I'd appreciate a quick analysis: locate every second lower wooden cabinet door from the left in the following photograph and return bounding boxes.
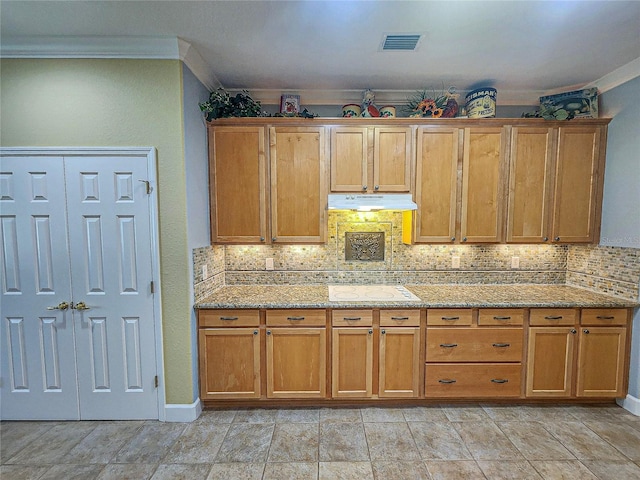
[267,327,327,398]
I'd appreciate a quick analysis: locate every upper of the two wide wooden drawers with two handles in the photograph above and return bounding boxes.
[427,328,523,362]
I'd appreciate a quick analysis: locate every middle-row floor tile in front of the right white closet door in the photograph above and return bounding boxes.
[61,422,142,464]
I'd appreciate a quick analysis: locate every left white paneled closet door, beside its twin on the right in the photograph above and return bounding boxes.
[0,157,80,420]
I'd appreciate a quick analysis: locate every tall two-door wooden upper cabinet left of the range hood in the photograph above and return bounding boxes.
[209,124,328,244]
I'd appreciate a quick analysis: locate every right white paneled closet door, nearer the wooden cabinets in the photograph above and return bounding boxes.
[65,156,158,419]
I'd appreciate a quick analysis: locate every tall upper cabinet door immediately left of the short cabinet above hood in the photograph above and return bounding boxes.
[270,127,327,243]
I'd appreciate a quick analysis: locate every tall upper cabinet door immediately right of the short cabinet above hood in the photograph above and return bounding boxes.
[414,127,459,243]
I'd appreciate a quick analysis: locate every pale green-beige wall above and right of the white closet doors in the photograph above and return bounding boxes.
[0,59,195,403]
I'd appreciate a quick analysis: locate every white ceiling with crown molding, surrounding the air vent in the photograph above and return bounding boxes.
[0,0,640,104]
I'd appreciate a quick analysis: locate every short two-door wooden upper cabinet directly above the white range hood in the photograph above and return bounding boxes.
[330,126,413,193]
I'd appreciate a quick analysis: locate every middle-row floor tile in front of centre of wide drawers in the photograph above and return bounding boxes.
[454,421,523,461]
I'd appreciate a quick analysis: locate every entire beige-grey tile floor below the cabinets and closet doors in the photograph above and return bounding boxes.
[0,404,640,480]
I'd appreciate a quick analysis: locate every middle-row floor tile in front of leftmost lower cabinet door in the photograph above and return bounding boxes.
[216,423,274,463]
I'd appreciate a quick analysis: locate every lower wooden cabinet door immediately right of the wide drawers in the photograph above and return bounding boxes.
[526,326,577,397]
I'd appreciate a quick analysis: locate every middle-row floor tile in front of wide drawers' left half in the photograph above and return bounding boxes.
[408,422,473,460]
